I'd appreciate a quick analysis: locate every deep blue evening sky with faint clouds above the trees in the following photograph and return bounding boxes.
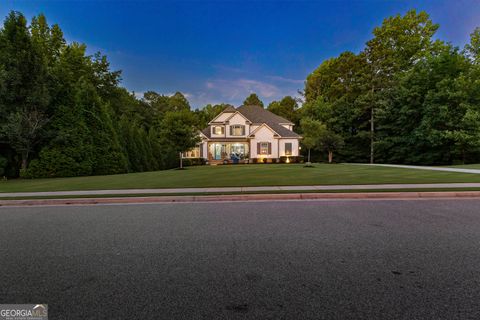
[0,0,480,107]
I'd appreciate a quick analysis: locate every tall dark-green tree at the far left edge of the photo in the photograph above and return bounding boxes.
[0,12,50,170]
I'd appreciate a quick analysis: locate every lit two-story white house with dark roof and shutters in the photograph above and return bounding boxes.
[185,105,301,164]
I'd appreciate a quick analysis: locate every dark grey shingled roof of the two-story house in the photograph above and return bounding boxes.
[202,105,301,139]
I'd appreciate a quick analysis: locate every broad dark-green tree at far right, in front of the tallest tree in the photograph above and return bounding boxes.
[375,43,474,164]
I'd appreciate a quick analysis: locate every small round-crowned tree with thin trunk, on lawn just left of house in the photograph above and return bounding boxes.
[159,110,199,169]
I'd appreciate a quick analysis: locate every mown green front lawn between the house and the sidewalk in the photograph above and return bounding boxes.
[0,164,480,192]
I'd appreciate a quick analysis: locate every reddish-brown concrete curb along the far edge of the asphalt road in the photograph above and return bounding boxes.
[0,191,480,207]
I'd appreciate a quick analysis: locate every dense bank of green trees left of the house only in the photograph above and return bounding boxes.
[0,12,201,178]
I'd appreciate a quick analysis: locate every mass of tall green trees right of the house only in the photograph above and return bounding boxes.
[298,10,480,165]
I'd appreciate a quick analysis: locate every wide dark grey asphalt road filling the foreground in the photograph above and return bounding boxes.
[0,200,480,320]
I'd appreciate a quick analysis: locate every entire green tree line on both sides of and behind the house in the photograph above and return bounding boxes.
[0,10,480,178]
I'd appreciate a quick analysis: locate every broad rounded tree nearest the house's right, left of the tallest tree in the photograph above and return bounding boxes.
[306,52,370,162]
